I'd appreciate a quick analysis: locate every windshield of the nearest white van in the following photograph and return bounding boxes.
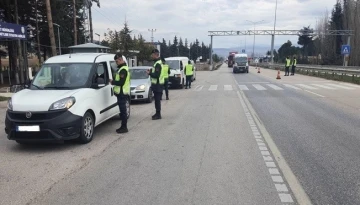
[30,63,93,90]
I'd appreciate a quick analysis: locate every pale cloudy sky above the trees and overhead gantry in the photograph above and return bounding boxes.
[92,0,336,50]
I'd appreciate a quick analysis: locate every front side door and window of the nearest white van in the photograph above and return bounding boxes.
[94,62,116,122]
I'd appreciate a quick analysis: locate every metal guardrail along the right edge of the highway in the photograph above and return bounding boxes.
[250,63,360,84]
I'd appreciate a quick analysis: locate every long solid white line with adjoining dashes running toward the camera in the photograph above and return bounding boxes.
[237,91,311,204]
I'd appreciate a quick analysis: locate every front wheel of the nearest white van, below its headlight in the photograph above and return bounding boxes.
[78,112,95,144]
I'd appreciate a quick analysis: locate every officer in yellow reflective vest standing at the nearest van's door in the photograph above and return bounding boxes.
[110,53,130,134]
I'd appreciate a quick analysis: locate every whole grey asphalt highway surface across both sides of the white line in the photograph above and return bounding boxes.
[0,64,360,205]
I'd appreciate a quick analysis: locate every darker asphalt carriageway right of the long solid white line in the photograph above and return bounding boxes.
[229,68,360,204]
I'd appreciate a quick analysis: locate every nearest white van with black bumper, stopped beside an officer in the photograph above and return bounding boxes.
[5,53,130,144]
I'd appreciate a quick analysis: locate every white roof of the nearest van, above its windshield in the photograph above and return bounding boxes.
[45,53,115,63]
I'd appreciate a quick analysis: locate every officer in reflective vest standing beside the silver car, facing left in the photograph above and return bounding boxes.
[147,49,165,120]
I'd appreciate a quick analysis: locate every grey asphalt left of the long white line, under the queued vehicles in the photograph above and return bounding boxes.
[0,67,296,205]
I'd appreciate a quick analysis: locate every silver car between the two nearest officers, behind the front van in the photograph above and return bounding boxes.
[129,66,153,103]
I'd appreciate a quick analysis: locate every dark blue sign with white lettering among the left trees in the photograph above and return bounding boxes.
[0,22,27,40]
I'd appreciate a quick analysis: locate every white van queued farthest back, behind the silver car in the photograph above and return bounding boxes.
[165,57,196,88]
